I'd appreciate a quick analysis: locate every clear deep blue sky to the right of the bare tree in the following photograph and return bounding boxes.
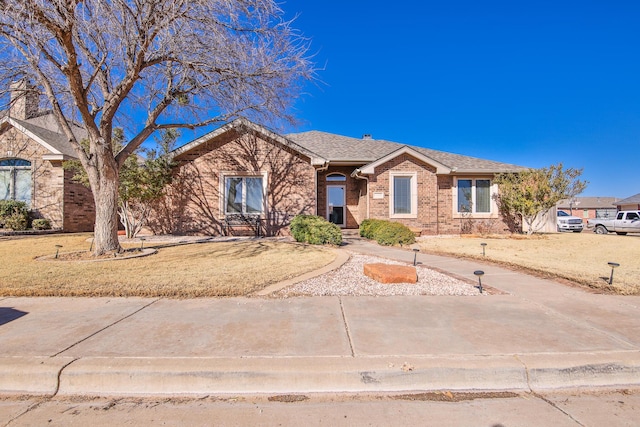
[282,0,640,198]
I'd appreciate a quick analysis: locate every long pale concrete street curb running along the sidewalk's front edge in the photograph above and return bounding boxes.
[0,351,624,396]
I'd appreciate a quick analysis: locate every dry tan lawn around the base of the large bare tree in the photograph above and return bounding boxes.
[0,234,335,298]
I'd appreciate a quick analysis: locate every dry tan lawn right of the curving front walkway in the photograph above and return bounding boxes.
[420,231,640,295]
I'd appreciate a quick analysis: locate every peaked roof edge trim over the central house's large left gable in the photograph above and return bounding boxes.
[172,118,327,166]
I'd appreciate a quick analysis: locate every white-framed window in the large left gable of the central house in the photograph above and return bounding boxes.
[224,176,264,214]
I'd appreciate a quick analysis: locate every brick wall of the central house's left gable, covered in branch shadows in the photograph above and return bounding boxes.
[149,131,316,235]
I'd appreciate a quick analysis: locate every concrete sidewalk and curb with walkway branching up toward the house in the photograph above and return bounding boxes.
[0,238,640,395]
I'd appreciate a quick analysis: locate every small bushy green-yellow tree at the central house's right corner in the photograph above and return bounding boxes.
[493,163,587,235]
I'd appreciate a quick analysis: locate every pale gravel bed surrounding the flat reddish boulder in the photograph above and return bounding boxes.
[272,254,485,298]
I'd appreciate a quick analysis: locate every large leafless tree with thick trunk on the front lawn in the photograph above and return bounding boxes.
[0,0,313,255]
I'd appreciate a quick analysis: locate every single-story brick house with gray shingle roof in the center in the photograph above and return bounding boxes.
[150,119,524,235]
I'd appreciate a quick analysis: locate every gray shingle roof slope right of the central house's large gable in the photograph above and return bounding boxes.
[285,131,525,173]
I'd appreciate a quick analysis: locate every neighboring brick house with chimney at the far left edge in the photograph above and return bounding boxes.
[0,81,95,232]
